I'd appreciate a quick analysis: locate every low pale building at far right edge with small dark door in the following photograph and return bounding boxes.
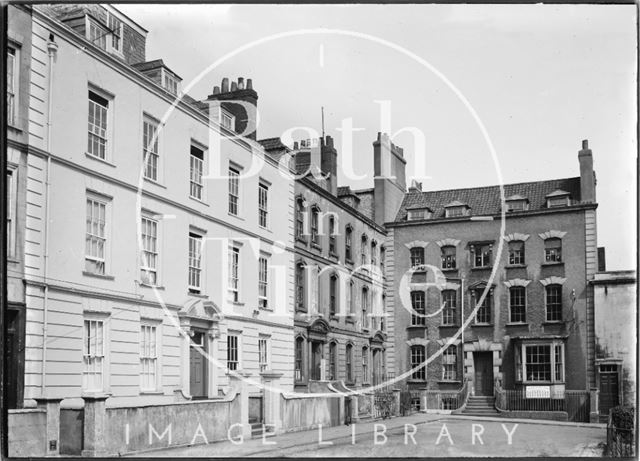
[591,271,638,417]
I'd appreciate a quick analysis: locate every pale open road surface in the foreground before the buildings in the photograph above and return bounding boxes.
[124,413,606,458]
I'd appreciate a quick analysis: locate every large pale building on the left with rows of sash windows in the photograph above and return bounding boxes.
[19,5,294,406]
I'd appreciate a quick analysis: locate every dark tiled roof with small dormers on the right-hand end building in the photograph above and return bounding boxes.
[395,177,580,222]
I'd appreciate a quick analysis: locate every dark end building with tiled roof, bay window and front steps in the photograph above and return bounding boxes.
[388,141,597,402]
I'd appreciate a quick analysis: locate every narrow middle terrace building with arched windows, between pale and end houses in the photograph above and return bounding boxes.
[262,134,405,392]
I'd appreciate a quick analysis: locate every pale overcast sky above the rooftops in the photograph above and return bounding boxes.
[118,5,637,270]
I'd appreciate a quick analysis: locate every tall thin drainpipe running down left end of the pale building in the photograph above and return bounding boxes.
[40,34,58,396]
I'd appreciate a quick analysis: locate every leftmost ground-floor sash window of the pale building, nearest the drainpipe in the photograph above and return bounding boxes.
[82,315,109,392]
